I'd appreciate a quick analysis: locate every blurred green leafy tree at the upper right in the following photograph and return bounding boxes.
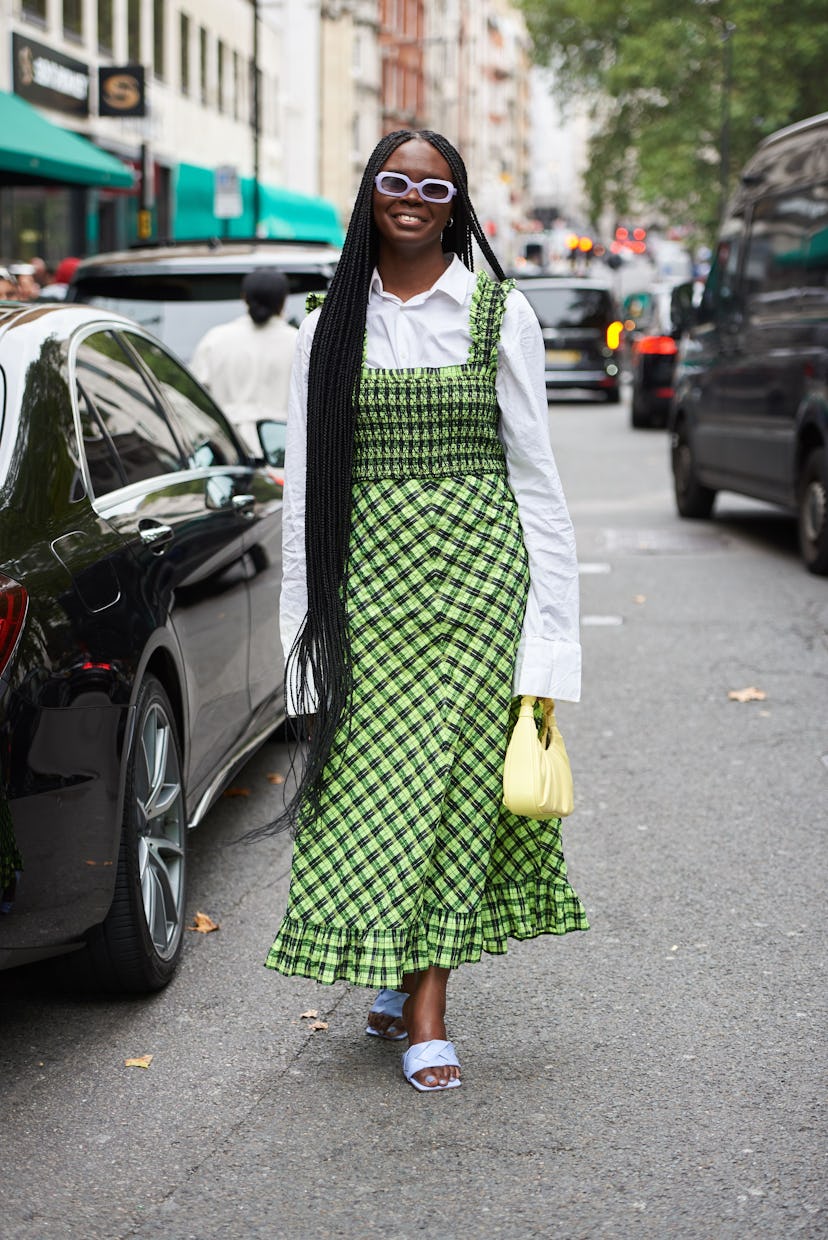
[517,0,828,237]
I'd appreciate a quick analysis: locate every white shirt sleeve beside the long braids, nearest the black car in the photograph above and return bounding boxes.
[279,311,319,714]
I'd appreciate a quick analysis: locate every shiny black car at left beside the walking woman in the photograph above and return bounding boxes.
[0,303,284,992]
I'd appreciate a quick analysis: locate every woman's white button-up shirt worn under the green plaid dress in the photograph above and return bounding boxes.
[280,255,581,711]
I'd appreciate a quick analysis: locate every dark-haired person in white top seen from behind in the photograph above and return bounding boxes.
[190,267,297,456]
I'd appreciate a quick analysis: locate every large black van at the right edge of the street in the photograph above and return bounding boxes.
[669,113,828,574]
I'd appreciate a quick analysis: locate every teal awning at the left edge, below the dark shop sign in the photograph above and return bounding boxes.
[0,91,133,190]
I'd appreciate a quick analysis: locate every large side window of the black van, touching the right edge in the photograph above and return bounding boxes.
[742,185,828,306]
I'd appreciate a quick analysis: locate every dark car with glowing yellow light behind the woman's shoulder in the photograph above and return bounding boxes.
[516,275,622,404]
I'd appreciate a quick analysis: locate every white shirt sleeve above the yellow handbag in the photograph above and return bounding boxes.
[497,283,581,702]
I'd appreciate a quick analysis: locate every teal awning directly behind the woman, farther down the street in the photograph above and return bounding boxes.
[174,164,345,246]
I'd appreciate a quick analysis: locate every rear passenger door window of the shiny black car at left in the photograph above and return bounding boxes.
[74,331,183,494]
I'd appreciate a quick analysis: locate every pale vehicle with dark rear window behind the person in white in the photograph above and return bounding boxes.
[67,238,340,362]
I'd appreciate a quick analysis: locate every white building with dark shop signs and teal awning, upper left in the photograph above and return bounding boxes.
[0,0,338,260]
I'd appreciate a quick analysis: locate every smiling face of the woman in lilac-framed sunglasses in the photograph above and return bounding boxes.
[373,138,454,253]
